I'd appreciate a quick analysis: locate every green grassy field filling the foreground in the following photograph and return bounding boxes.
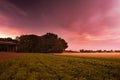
[0,54,120,80]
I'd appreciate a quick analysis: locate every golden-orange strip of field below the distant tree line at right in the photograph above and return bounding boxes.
[55,53,120,59]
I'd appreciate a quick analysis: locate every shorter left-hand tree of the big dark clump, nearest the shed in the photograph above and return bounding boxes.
[18,35,39,52]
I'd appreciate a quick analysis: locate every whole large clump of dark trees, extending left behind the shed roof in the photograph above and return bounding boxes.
[0,33,68,53]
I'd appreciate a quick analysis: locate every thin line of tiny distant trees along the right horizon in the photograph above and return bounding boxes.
[80,49,120,53]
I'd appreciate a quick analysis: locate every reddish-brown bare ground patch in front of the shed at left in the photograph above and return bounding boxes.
[0,52,23,62]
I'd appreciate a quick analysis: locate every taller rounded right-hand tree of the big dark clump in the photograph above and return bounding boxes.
[40,33,68,53]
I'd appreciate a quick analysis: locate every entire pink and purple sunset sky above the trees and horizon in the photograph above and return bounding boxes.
[0,0,120,50]
